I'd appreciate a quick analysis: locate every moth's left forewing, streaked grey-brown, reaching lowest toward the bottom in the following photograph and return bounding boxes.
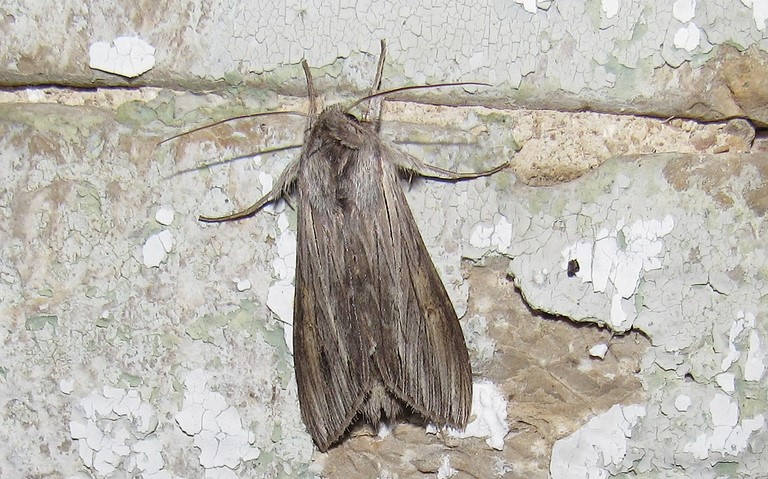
[293,153,371,451]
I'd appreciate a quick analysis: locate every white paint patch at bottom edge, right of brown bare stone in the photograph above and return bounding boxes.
[549,404,645,479]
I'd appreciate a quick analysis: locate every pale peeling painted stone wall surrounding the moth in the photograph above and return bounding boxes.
[0,0,768,479]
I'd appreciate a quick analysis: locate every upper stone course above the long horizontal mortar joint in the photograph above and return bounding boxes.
[0,0,768,125]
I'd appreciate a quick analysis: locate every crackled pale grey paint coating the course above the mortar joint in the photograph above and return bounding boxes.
[4,0,768,110]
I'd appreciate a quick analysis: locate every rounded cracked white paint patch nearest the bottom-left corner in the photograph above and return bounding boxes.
[69,386,164,477]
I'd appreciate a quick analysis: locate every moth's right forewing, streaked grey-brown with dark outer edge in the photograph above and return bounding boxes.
[361,156,472,428]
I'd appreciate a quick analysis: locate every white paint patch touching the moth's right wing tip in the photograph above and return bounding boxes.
[449,381,509,451]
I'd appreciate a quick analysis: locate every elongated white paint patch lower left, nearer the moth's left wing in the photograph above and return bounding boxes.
[175,369,260,477]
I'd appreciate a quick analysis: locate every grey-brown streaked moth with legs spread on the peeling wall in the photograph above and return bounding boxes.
[200,42,507,451]
